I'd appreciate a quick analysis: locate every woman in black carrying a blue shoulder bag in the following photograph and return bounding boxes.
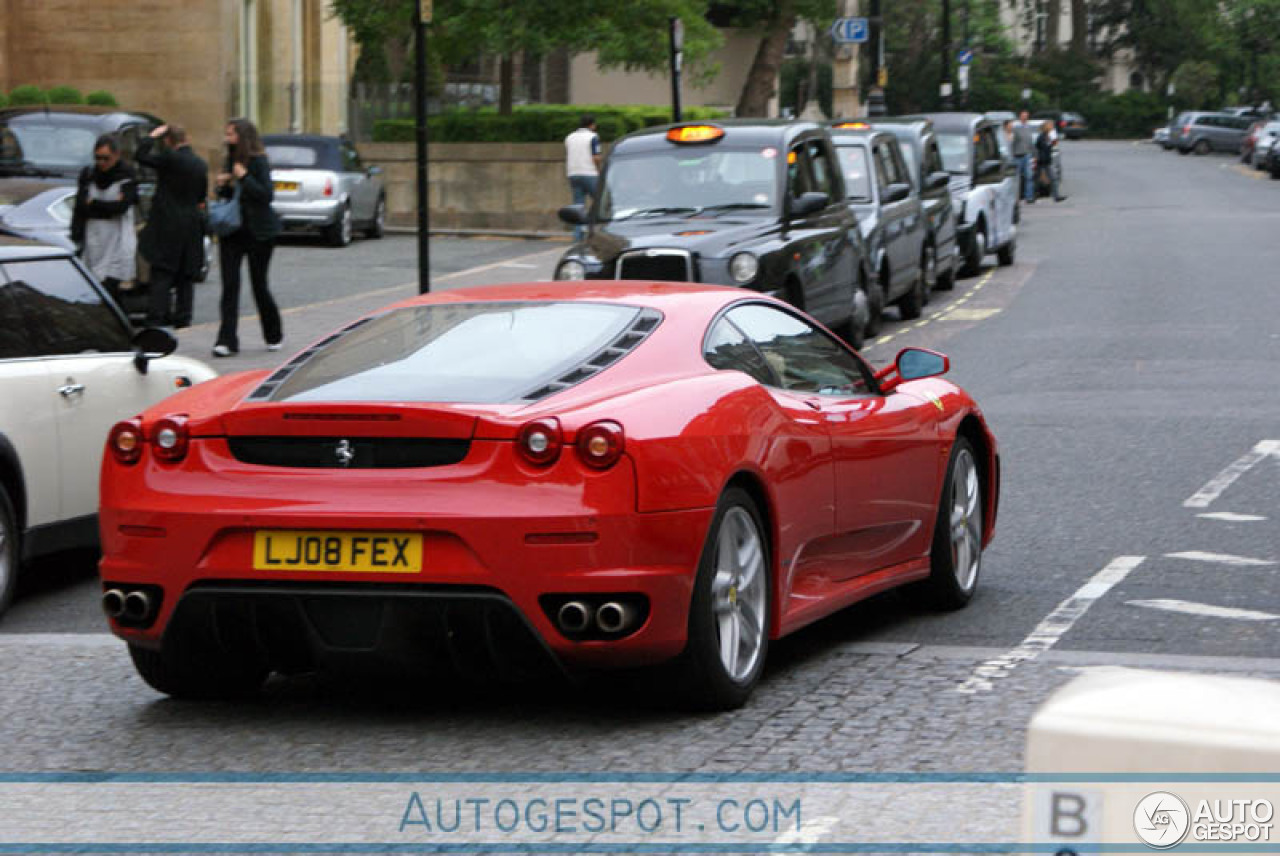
[214,119,284,357]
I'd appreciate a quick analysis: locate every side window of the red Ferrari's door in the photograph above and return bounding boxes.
[727,303,873,397]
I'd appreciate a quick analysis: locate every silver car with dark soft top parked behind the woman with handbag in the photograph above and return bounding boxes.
[262,134,387,247]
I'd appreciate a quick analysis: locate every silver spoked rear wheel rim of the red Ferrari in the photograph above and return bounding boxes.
[712,505,768,681]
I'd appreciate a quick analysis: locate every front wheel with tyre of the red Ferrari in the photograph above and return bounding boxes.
[918,438,983,609]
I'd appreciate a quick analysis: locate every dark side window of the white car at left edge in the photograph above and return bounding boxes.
[5,258,132,357]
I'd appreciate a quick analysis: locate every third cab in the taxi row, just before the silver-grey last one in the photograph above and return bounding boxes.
[874,114,962,292]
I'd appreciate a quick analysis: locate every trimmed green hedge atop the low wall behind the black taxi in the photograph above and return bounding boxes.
[374,104,726,142]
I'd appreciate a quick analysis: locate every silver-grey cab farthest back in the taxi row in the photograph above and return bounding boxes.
[924,113,1019,274]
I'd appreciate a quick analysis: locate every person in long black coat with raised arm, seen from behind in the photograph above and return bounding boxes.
[137,125,209,329]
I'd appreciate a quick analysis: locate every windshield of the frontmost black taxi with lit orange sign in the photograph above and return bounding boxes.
[599,146,778,220]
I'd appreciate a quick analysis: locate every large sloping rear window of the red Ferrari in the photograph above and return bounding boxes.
[271,302,643,404]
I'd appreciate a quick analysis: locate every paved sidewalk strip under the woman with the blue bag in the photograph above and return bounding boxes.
[177,242,564,375]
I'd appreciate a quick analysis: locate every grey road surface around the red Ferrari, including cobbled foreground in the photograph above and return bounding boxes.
[0,142,1280,788]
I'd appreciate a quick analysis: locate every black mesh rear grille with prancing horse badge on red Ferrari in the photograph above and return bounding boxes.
[227,436,471,470]
